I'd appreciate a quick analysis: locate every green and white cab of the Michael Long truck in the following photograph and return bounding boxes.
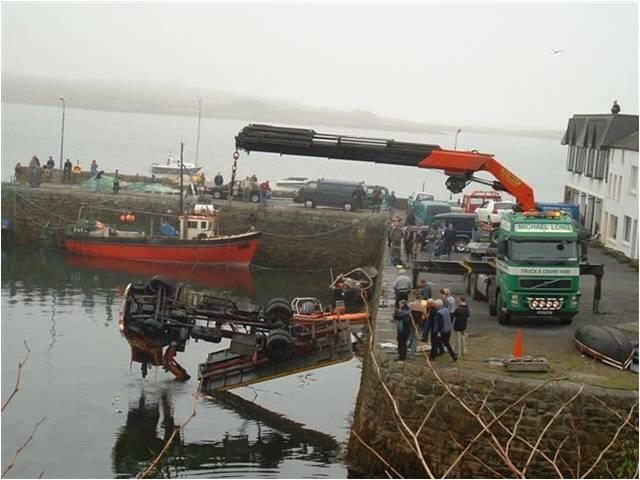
[487,212,580,325]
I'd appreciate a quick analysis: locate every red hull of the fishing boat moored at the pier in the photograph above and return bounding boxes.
[64,232,261,265]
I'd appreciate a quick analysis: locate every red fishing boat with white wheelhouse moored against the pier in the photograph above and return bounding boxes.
[64,206,261,266]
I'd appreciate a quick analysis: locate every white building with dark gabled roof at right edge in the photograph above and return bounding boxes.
[562,114,638,259]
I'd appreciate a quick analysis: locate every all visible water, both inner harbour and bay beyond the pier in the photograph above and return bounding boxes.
[1,104,564,478]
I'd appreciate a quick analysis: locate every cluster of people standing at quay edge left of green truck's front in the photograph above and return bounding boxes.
[393,269,470,361]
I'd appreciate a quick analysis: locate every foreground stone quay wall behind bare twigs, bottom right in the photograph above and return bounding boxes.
[347,353,638,478]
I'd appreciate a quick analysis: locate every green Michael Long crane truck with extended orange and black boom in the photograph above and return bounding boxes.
[234,124,604,324]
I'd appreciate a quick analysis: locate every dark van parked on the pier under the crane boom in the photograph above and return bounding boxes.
[293,178,366,211]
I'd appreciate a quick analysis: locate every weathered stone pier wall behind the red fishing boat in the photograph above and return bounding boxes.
[2,184,386,272]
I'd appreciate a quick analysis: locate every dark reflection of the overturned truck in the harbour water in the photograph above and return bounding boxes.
[112,389,339,478]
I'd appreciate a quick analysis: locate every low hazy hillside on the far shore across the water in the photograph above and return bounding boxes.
[2,74,562,139]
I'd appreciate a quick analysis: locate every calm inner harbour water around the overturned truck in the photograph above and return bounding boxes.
[2,249,360,478]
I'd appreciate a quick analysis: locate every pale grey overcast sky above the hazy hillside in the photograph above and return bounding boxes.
[2,2,638,129]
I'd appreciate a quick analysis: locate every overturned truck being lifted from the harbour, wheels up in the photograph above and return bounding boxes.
[119,267,377,391]
